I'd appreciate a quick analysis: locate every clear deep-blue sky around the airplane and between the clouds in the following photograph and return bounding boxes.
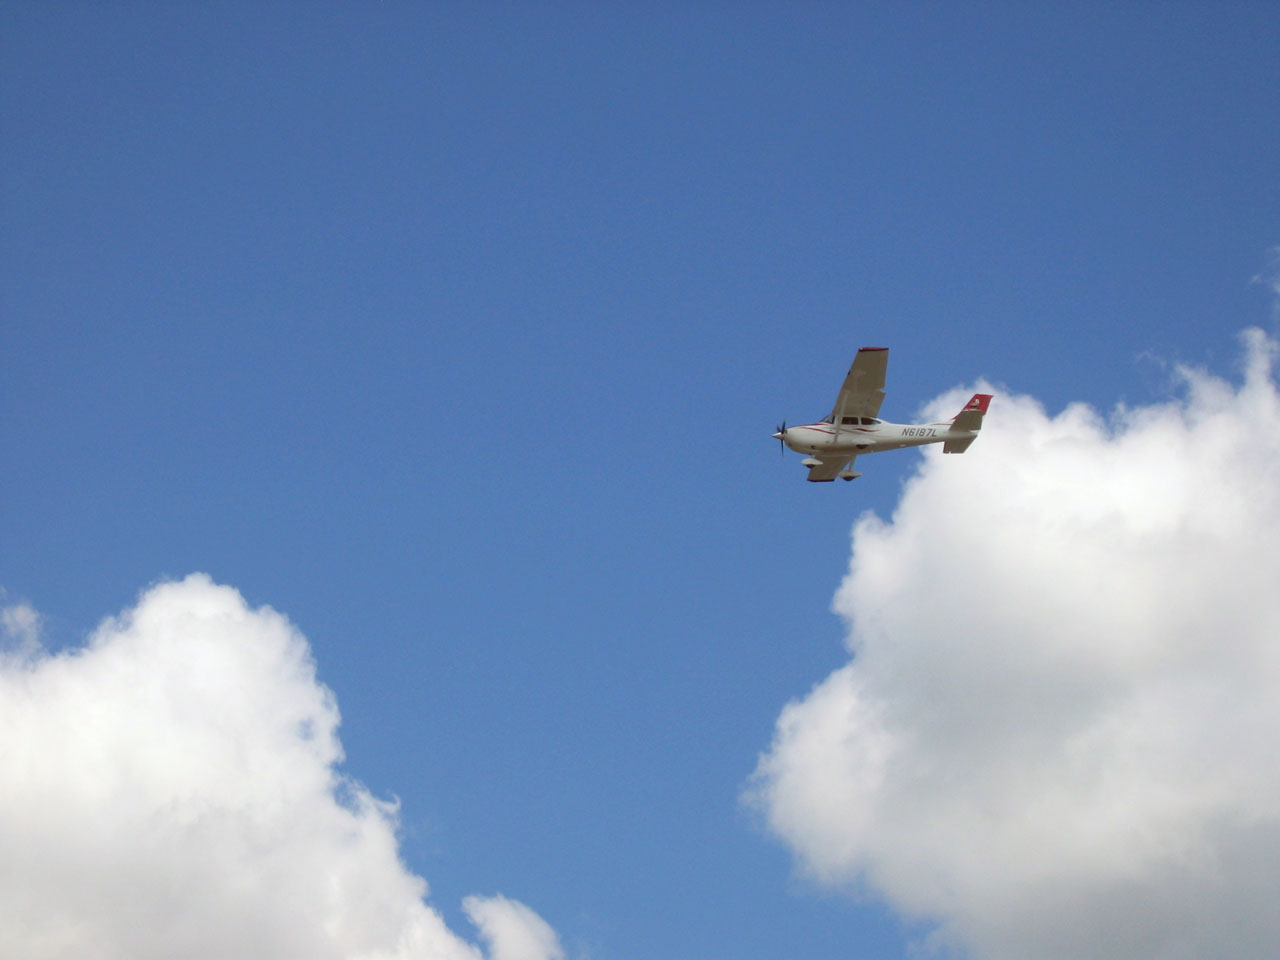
[0,3,1280,960]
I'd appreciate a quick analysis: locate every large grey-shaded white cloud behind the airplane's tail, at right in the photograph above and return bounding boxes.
[749,330,1280,960]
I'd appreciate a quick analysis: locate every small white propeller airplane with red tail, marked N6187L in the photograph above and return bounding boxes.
[773,347,991,483]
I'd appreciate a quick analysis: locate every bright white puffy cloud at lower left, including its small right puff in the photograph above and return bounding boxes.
[0,575,562,960]
